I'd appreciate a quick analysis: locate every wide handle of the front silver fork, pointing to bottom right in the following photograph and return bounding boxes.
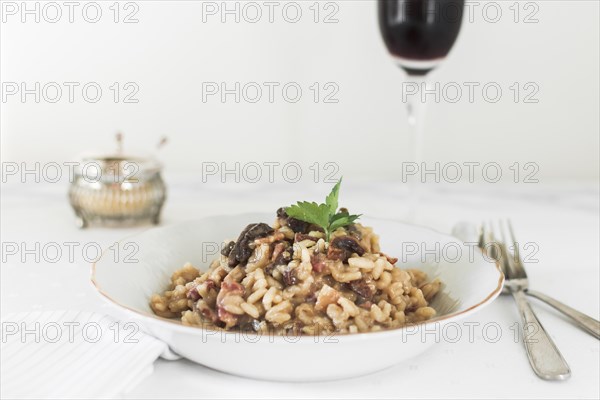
[512,290,571,380]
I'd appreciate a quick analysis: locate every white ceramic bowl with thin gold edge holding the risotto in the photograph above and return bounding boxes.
[92,214,504,381]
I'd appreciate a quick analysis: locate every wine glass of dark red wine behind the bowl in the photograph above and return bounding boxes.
[378,0,465,216]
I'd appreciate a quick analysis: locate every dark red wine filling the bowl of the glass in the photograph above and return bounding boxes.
[378,0,465,75]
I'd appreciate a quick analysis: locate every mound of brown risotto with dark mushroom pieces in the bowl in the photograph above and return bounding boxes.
[150,208,441,335]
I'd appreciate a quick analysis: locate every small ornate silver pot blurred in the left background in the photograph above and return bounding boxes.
[69,155,166,228]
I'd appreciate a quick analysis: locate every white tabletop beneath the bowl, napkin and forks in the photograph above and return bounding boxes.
[1,177,600,399]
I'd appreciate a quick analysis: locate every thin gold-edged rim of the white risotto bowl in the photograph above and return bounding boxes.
[90,213,505,343]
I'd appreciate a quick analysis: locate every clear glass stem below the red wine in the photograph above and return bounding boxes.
[403,75,427,222]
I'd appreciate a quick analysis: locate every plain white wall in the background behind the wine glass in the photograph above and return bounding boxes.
[0,0,600,180]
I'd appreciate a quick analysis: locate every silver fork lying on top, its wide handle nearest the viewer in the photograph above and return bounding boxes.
[482,221,571,380]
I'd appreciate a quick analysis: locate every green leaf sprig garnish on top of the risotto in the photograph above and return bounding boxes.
[285,178,360,241]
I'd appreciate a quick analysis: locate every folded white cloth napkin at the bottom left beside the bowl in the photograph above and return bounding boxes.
[0,311,172,399]
